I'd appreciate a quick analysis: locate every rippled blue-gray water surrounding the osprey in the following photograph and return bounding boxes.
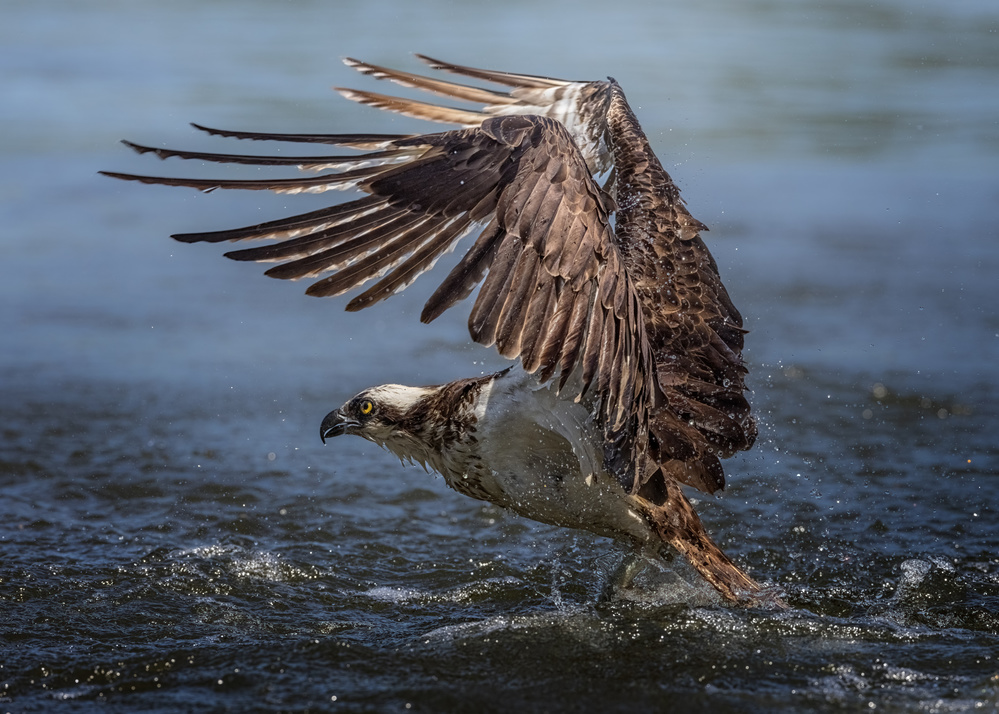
[0,0,999,712]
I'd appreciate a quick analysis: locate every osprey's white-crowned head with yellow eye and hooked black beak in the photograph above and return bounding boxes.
[319,384,436,458]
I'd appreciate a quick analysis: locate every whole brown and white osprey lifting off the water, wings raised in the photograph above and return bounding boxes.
[105,55,779,603]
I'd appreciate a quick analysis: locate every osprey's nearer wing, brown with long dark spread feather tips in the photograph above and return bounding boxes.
[108,116,654,476]
